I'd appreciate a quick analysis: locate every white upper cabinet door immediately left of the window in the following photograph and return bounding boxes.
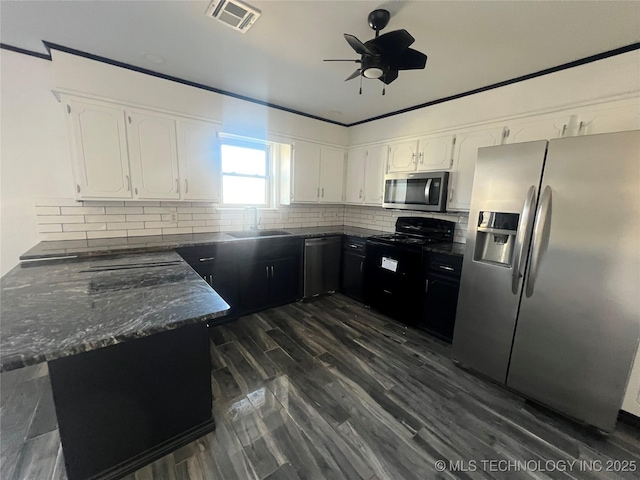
[178,120,221,202]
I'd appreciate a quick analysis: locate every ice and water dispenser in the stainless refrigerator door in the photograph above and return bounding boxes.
[473,211,520,268]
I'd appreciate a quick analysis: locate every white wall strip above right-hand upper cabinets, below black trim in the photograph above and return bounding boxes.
[349,50,640,146]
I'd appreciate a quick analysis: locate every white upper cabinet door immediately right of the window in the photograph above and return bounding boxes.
[291,142,320,203]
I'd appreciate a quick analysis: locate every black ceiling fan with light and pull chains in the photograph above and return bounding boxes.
[325,9,427,95]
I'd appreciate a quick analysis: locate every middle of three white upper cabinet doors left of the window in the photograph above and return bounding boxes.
[127,111,180,199]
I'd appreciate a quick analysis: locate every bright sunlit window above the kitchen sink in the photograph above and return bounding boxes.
[220,139,271,206]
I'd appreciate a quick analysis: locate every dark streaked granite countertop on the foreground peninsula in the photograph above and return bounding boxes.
[0,252,229,372]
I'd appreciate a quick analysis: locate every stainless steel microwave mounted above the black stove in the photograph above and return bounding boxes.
[382,172,449,212]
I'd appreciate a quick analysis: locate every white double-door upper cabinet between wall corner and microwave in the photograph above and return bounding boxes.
[345,145,388,206]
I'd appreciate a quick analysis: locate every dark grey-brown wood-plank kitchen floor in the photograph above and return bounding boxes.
[0,294,640,480]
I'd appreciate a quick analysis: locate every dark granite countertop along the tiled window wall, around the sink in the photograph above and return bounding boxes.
[20,225,383,260]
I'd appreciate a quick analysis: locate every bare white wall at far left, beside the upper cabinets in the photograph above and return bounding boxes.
[0,50,73,275]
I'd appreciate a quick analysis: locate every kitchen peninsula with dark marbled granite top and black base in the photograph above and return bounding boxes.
[0,252,229,480]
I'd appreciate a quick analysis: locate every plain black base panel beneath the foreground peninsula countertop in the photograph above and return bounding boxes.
[49,322,215,480]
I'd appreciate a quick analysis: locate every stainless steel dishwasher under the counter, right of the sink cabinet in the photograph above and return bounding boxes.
[304,237,342,298]
